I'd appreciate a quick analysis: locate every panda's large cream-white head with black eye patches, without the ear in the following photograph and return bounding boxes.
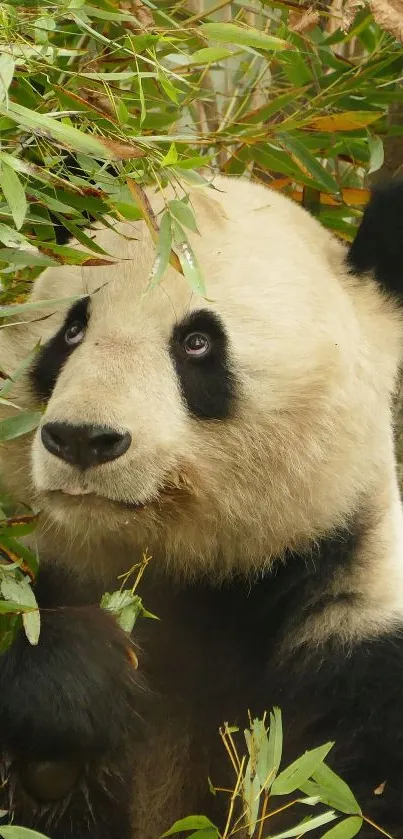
[0,178,401,575]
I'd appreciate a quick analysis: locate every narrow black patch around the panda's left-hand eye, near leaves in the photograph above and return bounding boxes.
[30,297,90,401]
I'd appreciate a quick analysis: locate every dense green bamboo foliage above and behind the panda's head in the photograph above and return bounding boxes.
[0,0,403,316]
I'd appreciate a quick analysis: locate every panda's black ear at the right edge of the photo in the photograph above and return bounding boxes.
[347,179,403,299]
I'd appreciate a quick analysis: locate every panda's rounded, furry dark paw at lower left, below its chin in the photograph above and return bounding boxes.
[0,606,144,760]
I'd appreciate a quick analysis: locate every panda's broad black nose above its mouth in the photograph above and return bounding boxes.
[41,422,132,469]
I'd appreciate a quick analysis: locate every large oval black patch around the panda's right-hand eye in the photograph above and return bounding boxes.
[170,309,236,419]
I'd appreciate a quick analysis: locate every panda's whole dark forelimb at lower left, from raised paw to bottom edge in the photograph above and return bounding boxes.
[0,566,145,839]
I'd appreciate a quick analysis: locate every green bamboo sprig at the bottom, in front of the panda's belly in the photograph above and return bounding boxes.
[161,708,393,839]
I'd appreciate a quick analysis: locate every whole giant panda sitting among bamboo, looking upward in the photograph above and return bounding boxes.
[0,176,403,839]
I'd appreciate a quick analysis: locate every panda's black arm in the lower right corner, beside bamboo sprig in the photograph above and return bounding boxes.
[274,632,403,839]
